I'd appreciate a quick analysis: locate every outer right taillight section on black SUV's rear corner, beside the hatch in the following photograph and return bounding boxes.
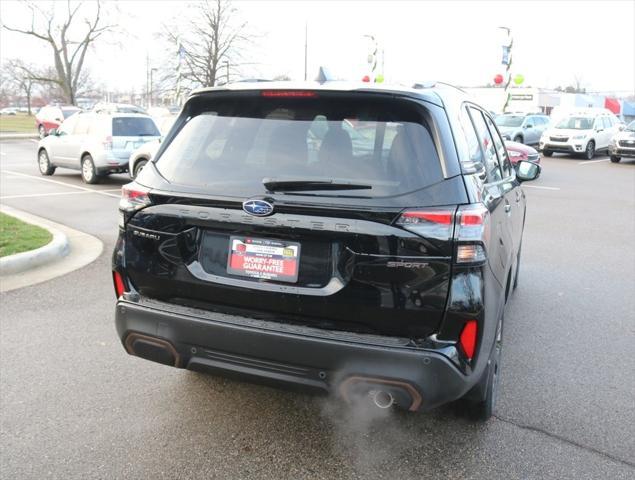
[454,204,490,263]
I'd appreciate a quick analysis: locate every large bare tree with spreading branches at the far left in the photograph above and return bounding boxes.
[3,0,113,105]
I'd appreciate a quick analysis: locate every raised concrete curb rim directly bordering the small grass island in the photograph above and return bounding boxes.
[0,206,70,276]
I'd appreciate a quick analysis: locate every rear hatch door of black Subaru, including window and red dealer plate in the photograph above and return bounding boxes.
[126,94,465,337]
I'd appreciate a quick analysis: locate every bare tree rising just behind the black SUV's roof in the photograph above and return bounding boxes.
[164,0,251,87]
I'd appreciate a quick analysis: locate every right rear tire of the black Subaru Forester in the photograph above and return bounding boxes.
[466,316,503,422]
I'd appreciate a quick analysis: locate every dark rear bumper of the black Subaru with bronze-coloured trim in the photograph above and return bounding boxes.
[116,297,475,410]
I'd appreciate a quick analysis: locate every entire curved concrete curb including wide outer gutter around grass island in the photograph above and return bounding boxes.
[0,205,103,292]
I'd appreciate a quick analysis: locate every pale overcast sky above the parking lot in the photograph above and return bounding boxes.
[0,0,635,93]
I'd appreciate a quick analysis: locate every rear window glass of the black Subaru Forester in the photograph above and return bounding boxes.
[157,94,443,197]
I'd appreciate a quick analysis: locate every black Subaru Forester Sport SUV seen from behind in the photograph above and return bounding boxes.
[113,82,540,419]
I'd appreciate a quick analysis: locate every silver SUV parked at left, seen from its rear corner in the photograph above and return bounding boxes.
[37,112,160,183]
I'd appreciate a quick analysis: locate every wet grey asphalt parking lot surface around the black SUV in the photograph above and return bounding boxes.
[0,140,635,479]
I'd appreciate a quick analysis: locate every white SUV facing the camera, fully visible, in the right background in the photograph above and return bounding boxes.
[539,110,620,160]
